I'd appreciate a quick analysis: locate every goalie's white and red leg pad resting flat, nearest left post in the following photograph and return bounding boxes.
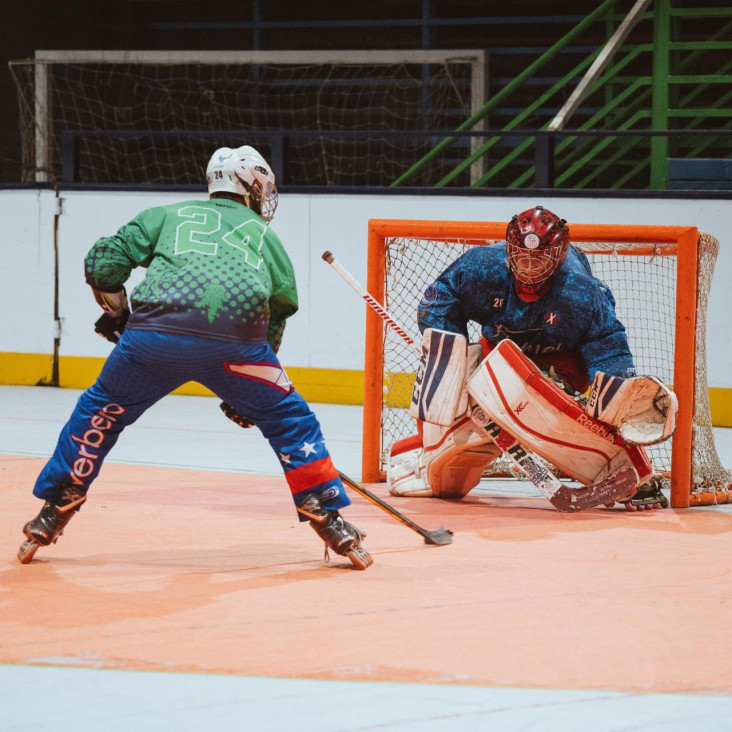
[387,417,501,498]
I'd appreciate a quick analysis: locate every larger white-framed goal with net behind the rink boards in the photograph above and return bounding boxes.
[9,49,487,186]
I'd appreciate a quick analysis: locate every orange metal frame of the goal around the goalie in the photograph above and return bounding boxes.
[362,219,727,508]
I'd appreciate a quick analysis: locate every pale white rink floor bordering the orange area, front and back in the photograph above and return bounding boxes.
[0,387,732,732]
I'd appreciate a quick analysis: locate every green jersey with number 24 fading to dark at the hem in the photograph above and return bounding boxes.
[84,198,297,350]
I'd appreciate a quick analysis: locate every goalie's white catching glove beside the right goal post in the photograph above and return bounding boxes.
[585,371,679,445]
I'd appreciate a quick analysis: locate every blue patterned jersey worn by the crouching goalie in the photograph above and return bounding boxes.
[418,242,635,381]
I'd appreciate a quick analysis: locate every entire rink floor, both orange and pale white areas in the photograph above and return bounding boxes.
[0,387,732,732]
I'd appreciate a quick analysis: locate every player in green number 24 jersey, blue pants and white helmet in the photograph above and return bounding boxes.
[19,145,372,569]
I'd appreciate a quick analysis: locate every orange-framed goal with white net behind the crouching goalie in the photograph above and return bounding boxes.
[362,220,732,507]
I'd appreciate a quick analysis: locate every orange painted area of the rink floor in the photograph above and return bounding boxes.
[0,456,732,694]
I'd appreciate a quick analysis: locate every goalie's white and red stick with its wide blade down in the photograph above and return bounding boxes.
[322,251,637,513]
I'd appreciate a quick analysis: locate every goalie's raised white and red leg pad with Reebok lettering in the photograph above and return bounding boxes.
[468,340,652,485]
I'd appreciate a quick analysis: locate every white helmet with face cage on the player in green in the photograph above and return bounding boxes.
[206,145,278,223]
